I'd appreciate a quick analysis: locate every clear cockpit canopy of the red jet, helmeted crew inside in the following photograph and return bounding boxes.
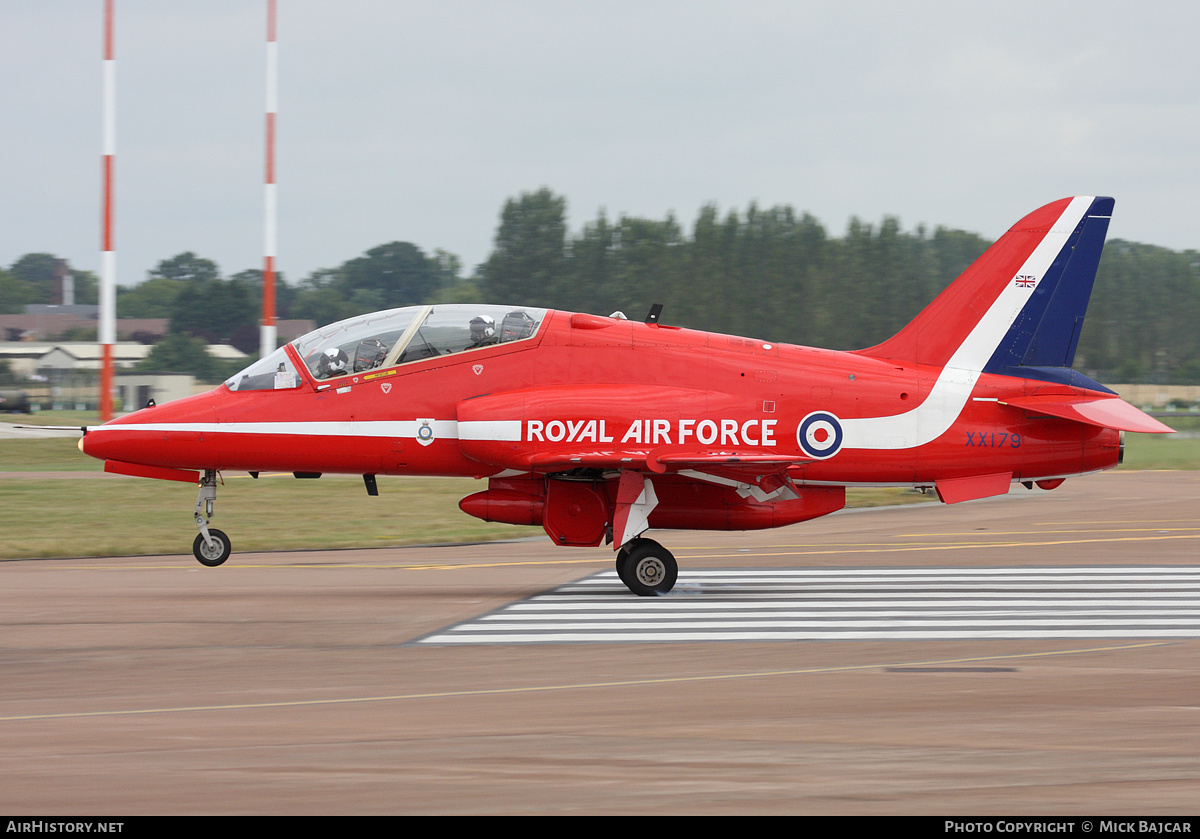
[226,304,546,390]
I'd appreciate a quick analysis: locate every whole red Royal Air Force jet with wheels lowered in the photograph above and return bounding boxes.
[79,197,1171,595]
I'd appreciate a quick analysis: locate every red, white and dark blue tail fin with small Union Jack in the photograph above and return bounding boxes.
[858,196,1114,392]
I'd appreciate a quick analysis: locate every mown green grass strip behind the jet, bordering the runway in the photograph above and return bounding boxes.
[0,435,1200,558]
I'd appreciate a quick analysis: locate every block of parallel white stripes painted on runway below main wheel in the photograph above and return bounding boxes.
[416,567,1200,645]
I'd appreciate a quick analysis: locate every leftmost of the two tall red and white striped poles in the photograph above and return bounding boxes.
[97,0,116,423]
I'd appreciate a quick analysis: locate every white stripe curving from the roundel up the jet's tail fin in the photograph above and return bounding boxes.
[841,197,1093,449]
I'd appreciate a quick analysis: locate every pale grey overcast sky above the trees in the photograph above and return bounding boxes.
[0,0,1200,284]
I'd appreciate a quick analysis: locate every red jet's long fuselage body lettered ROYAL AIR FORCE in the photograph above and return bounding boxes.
[84,312,1120,486]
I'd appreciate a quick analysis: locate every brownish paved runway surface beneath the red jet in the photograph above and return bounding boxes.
[0,473,1200,815]
